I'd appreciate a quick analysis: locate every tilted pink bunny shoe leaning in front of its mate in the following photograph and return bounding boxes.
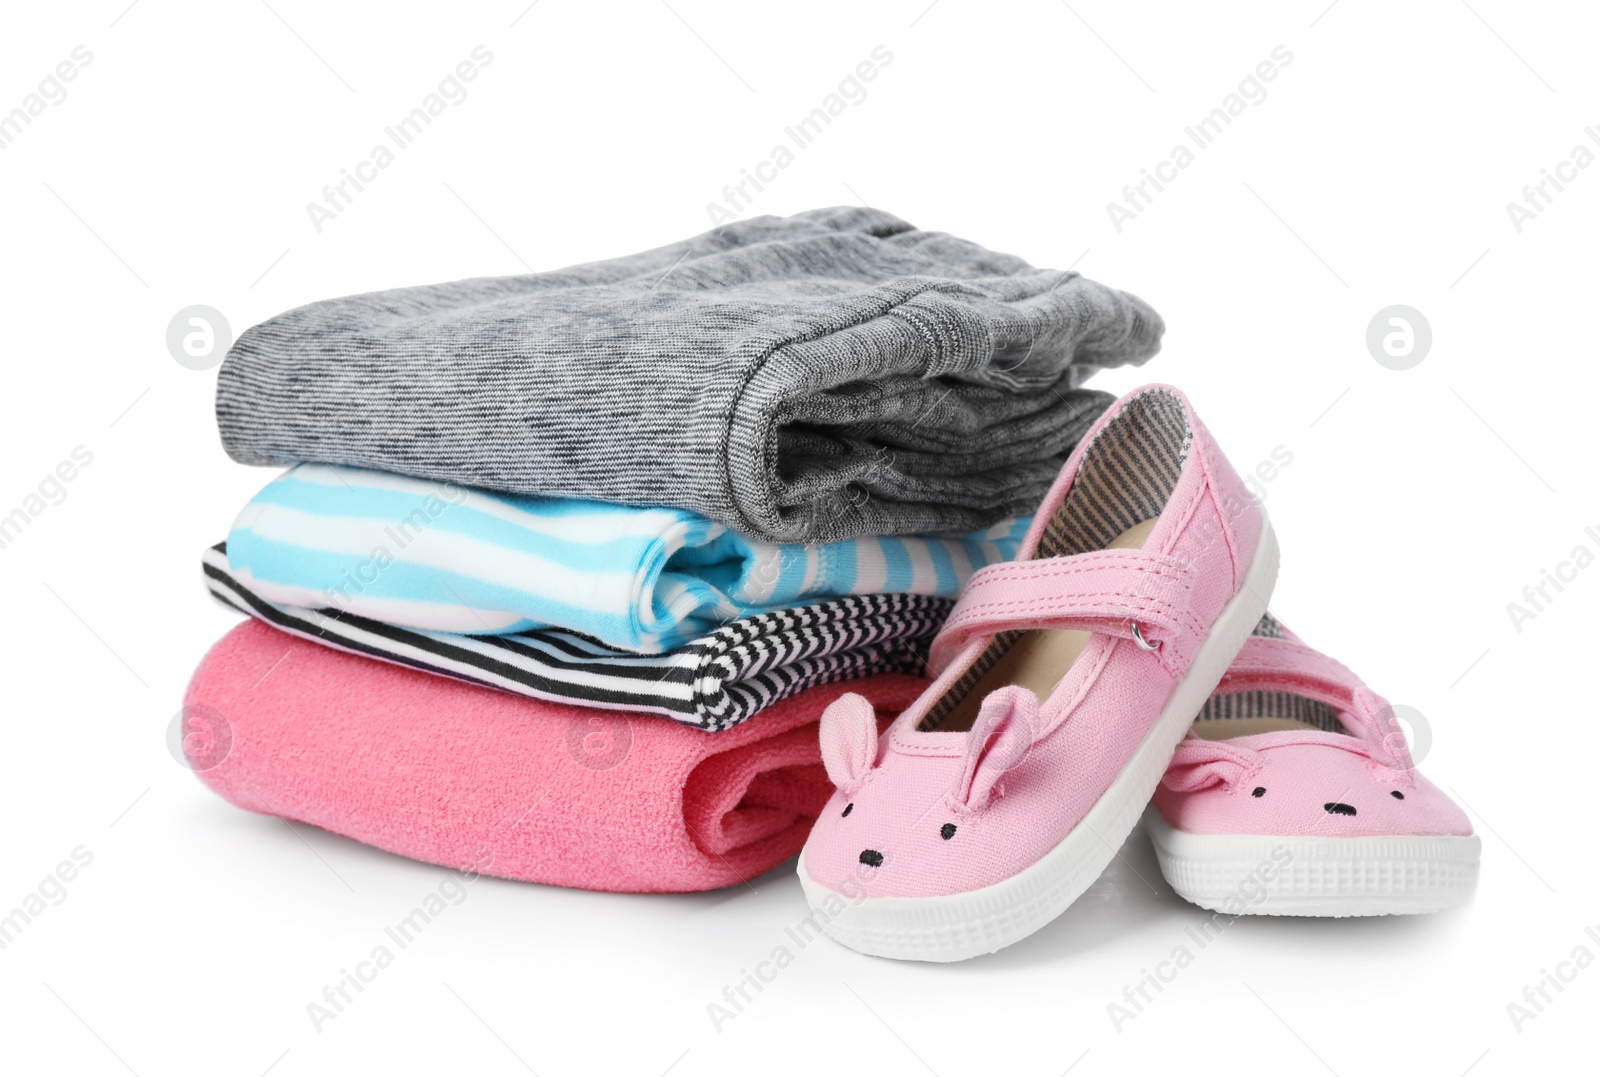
[800,386,1278,962]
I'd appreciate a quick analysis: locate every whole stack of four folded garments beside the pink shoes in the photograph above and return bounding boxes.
[186,208,1162,891]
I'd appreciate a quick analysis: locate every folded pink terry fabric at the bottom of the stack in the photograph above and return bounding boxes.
[186,621,926,893]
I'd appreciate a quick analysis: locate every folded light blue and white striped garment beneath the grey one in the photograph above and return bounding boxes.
[227,464,1029,653]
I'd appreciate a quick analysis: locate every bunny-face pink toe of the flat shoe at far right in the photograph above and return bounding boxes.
[1155,730,1472,837]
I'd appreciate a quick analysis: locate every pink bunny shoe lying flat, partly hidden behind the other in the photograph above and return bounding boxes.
[1149,615,1480,917]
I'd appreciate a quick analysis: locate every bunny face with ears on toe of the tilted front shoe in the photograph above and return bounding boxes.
[806,687,1040,896]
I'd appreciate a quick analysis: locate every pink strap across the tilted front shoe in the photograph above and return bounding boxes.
[930,551,1206,672]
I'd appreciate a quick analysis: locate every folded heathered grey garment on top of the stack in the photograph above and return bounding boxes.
[216,208,1163,543]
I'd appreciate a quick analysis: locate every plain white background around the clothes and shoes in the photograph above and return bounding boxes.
[0,0,1600,1077]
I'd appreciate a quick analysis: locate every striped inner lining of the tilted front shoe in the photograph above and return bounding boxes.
[917,389,1190,731]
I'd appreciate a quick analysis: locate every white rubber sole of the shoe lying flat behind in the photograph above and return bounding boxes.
[1146,808,1482,917]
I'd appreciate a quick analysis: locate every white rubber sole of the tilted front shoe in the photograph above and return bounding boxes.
[798,522,1278,962]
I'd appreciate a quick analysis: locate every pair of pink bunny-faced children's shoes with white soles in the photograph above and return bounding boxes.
[798,386,1478,962]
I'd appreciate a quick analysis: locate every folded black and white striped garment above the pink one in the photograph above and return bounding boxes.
[203,543,955,731]
